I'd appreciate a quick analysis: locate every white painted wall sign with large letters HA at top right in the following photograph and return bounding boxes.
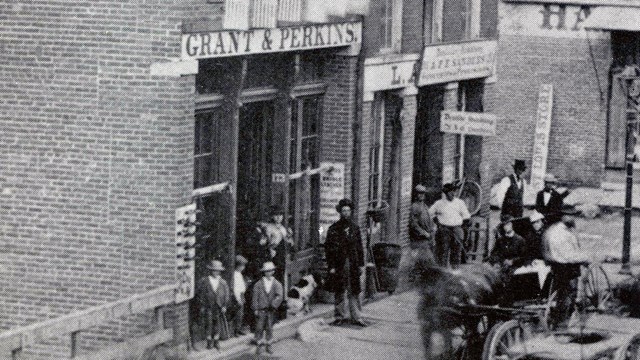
[499,1,609,39]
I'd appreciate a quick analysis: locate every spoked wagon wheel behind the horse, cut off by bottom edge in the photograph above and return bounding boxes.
[482,320,533,360]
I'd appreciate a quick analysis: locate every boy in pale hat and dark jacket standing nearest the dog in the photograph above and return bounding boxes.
[251,261,284,354]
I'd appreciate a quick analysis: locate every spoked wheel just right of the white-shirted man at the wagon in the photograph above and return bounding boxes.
[579,264,612,311]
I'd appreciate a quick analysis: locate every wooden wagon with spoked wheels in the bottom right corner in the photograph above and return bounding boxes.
[481,264,640,360]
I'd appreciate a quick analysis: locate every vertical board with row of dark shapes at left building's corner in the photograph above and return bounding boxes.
[175,204,196,303]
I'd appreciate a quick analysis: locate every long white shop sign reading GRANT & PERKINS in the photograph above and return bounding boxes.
[182,22,362,60]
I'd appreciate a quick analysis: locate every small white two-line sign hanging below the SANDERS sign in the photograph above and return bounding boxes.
[440,110,497,136]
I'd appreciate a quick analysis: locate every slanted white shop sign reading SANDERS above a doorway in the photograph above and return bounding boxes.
[418,40,498,86]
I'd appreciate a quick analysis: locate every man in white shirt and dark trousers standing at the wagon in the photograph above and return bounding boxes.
[542,210,589,328]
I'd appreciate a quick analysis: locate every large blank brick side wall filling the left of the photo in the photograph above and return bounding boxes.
[0,0,211,358]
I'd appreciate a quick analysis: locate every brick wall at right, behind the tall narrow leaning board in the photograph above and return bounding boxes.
[491,4,611,186]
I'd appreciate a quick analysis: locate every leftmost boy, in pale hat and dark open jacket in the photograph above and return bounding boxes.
[196,260,229,350]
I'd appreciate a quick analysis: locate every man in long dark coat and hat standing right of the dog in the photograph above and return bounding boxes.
[325,199,367,327]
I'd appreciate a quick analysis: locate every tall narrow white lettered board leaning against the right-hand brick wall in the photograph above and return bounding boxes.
[531,84,553,192]
